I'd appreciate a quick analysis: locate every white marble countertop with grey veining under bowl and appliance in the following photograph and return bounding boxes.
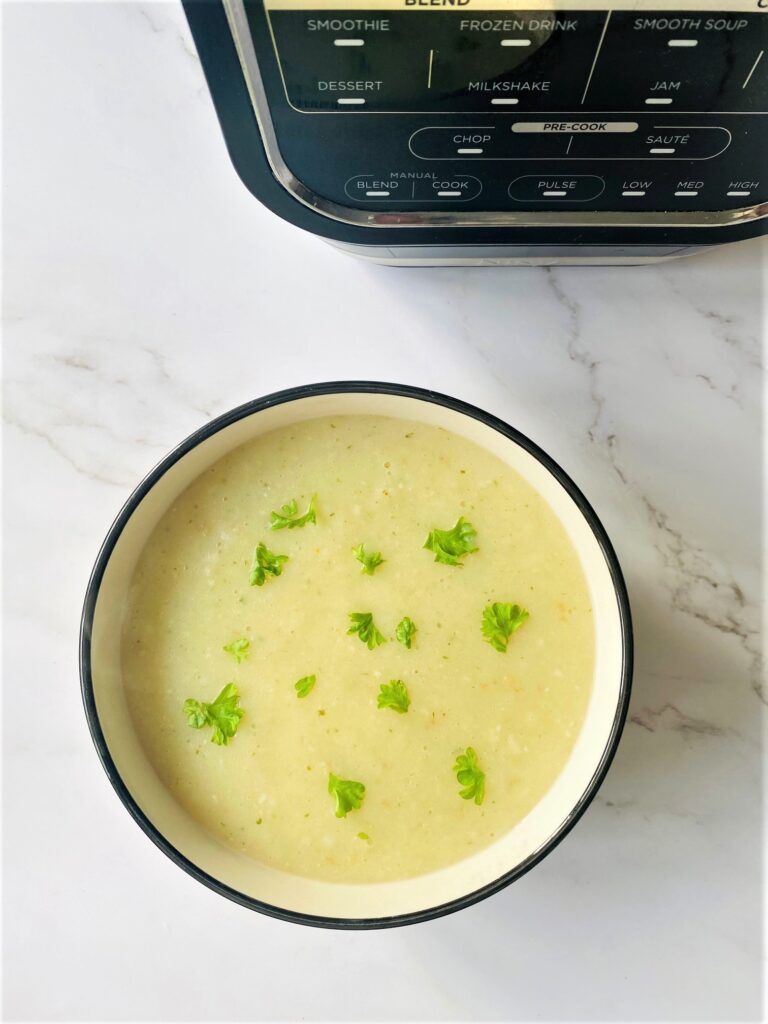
[4,3,766,1021]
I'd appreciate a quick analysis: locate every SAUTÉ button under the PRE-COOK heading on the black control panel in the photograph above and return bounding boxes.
[569,125,731,160]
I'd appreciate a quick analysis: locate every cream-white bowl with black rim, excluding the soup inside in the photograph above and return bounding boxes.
[81,382,632,928]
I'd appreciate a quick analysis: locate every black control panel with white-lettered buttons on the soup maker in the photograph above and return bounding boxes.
[247,0,768,215]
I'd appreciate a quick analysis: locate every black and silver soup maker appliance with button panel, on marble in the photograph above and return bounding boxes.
[183,0,768,265]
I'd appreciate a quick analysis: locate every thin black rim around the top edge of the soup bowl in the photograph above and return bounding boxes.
[80,381,633,930]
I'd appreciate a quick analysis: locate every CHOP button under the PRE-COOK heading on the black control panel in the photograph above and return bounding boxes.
[409,125,568,160]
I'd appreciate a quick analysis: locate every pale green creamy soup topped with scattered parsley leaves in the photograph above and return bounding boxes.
[122,416,594,882]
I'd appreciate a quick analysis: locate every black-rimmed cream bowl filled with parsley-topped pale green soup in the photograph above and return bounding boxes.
[81,382,632,928]
